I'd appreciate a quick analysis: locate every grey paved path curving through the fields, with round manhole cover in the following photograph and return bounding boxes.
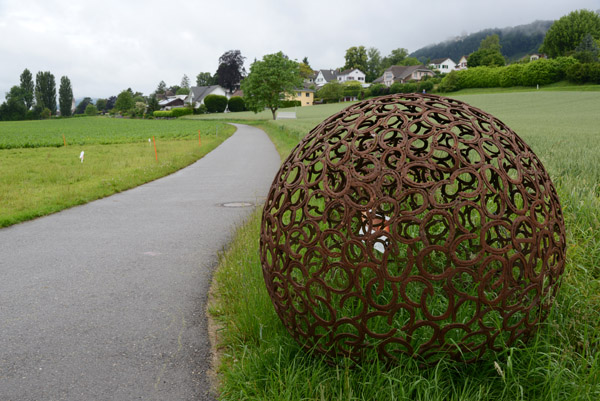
[0,125,280,401]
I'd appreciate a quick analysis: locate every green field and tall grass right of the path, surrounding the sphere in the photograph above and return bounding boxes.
[209,91,600,400]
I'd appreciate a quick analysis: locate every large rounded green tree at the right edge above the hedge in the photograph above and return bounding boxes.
[540,10,600,57]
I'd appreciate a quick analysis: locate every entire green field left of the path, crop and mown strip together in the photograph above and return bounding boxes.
[0,117,235,227]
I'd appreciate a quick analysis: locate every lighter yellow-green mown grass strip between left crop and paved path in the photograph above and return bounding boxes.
[0,126,235,227]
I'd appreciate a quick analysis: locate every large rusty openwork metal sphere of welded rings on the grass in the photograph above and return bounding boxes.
[260,94,565,362]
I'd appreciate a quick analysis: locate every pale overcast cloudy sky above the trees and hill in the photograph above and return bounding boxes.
[0,0,600,99]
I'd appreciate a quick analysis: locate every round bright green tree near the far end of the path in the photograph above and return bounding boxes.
[242,52,302,120]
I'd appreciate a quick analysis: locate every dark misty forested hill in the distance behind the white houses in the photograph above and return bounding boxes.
[410,21,554,63]
